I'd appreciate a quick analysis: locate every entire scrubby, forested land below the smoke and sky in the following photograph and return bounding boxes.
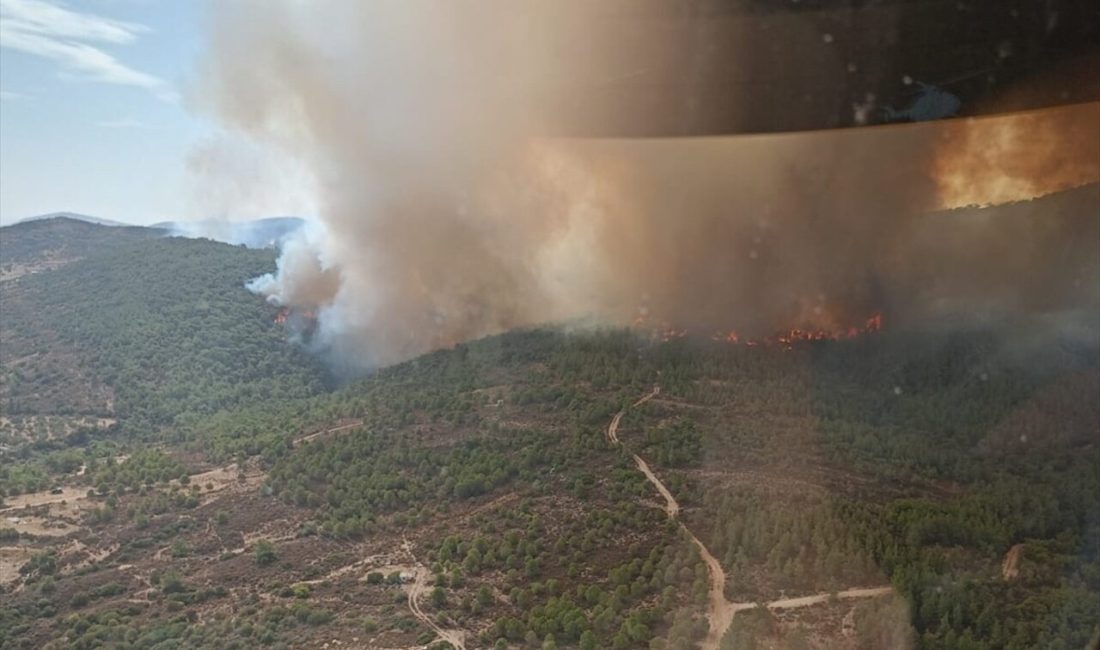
[0,218,1100,650]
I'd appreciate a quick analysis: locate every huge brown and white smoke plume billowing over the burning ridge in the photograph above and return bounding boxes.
[202,0,1100,367]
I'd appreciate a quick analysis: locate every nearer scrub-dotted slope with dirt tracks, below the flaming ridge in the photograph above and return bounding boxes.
[4,330,1100,649]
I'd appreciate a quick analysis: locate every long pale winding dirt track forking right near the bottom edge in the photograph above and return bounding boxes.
[607,386,893,650]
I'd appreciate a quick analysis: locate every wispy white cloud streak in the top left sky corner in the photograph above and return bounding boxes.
[0,0,178,101]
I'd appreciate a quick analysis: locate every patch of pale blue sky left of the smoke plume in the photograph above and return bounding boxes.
[0,0,217,223]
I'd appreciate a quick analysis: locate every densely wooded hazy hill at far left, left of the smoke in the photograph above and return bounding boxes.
[0,220,325,493]
